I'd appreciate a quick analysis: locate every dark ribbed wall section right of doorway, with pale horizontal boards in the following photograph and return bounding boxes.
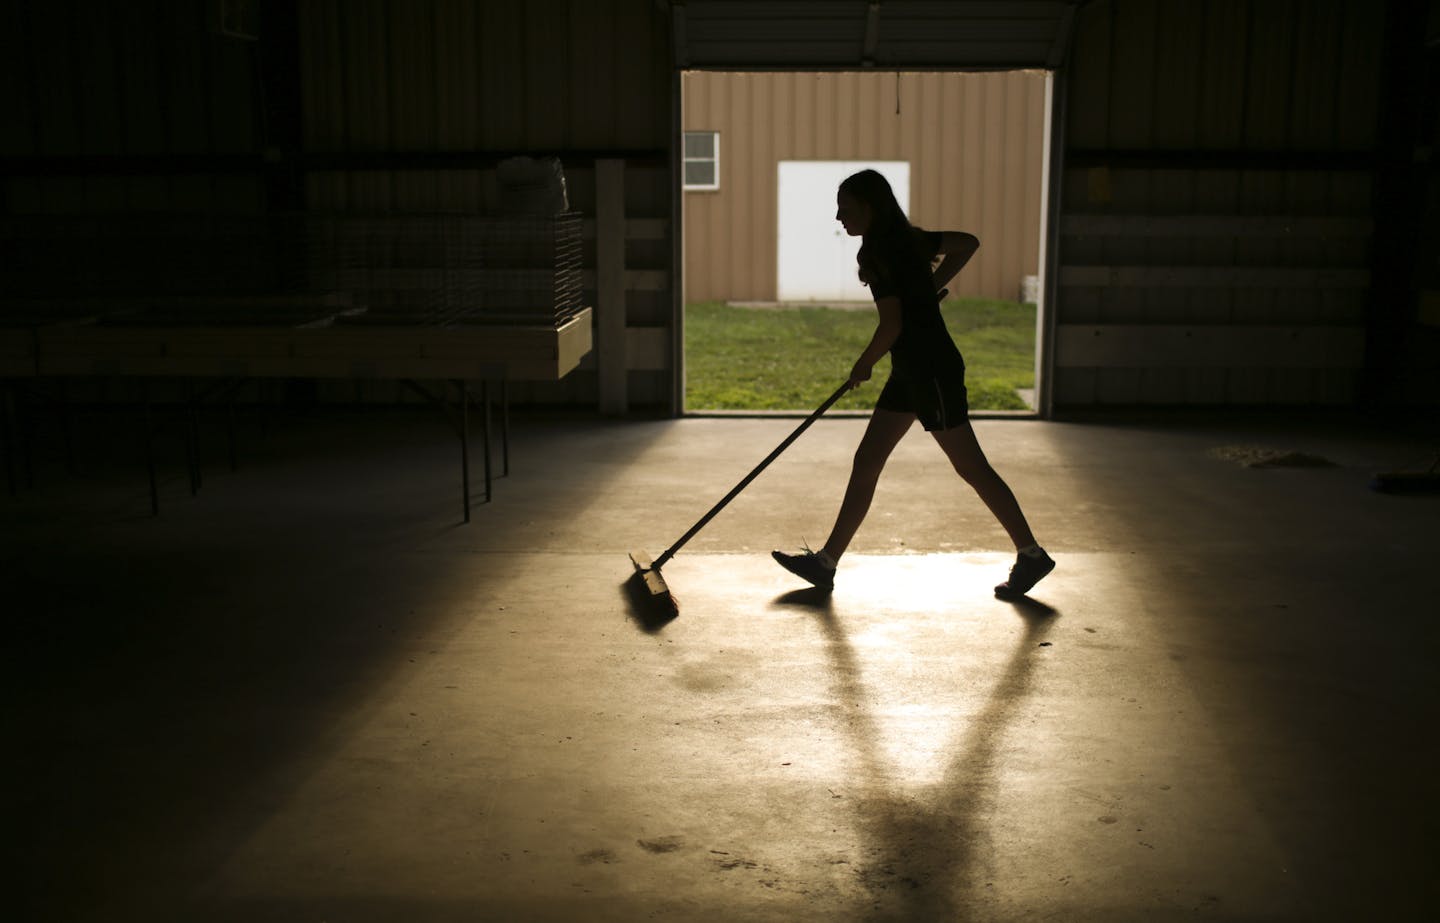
[1053,0,1384,408]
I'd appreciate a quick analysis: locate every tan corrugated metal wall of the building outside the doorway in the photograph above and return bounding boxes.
[683,71,1045,301]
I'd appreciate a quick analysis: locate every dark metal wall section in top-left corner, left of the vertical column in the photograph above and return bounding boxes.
[0,0,265,215]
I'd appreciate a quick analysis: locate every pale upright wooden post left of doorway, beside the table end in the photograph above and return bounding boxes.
[595,158,628,413]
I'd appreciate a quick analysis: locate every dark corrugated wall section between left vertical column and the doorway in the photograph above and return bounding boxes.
[300,0,674,405]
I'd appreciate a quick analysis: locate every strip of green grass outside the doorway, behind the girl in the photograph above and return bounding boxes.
[685,298,1035,410]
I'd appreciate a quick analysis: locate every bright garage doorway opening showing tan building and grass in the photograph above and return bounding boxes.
[681,71,1050,413]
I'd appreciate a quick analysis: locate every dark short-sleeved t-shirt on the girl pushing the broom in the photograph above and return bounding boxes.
[870,228,965,377]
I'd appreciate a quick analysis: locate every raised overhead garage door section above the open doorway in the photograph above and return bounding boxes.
[671,0,1083,71]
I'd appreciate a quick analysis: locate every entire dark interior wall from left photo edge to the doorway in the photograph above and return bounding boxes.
[0,0,672,405]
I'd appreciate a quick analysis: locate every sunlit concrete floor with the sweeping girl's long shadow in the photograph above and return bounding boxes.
[0,412,1440,922]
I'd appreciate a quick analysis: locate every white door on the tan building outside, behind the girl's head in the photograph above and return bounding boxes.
[775,160,910,301]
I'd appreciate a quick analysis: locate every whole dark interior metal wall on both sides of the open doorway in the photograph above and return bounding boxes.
[0,0,1440,406]
